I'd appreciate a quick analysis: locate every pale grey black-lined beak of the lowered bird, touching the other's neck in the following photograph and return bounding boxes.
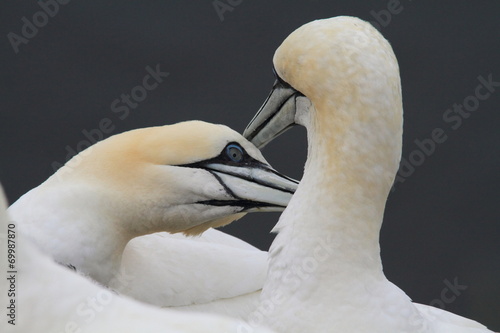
[203,161,299,212]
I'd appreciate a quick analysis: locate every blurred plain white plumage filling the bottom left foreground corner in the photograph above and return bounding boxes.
[0,186,276,333]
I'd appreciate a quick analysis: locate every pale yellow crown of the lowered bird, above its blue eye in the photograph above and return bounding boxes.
[58,120,251,184]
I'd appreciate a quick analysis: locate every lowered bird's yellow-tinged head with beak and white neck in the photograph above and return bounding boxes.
[9,121,297,284]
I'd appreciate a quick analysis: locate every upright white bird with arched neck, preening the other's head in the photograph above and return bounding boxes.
[244,17,489,333]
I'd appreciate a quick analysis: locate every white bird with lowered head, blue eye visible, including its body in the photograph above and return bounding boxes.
[9,121,297,315]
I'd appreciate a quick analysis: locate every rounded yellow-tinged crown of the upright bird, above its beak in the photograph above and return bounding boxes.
[273,16,399,108]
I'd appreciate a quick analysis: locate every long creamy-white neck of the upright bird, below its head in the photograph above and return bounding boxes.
[269,97,400,292]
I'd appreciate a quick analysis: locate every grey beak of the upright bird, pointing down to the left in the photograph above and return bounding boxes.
[243,78,305,149]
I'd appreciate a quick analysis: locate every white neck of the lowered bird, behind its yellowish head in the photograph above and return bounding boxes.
[9,182,134,285]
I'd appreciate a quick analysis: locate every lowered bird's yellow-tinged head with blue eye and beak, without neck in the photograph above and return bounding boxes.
[51,121,298,237]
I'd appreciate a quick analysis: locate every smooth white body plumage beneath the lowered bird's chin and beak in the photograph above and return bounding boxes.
[113,229,267,308]
